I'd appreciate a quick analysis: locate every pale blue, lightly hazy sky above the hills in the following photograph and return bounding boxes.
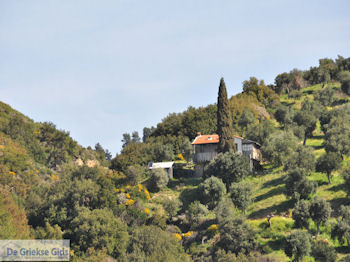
[0,0,350,154]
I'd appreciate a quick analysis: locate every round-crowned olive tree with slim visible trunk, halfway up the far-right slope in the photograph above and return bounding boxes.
[316,152,342,184]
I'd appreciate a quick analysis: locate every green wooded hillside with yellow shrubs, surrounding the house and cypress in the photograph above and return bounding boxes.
[0,56,350,261]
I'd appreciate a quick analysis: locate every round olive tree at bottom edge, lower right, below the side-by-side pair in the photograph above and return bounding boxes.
[284,230,311,262]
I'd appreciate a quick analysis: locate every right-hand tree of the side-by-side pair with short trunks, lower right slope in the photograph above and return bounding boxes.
[310,197,332,235]
